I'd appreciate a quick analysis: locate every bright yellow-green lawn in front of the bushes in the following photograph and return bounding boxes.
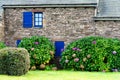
[0,71,120,80]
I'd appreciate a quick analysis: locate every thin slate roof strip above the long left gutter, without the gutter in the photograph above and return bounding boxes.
[0,0,97,5]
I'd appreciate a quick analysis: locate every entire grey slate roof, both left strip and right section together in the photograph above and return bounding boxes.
[0,0,120,20]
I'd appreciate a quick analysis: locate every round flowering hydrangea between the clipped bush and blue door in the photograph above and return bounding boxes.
[18,36,54,70]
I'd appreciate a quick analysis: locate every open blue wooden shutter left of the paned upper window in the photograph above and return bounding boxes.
[23,12,32,28]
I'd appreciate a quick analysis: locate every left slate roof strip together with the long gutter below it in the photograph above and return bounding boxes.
[2,0,97,7]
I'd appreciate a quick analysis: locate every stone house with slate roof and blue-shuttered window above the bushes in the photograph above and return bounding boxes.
[0,0,120,46]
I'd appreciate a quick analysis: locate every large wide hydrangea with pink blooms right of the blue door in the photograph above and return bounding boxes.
[61,36,120,71]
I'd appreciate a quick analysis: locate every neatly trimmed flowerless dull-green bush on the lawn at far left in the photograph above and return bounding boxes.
[0,48,30,76]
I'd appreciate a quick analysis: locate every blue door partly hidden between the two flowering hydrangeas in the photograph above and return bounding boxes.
[55,41,64,57]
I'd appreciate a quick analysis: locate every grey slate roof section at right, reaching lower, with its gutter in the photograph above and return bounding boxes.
[95,0,120,20]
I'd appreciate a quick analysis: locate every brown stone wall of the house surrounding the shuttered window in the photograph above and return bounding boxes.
[4,8,120,46]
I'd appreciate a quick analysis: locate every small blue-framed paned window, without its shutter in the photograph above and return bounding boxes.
[34,12,43,28]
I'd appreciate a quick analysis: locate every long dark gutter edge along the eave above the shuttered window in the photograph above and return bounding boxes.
[2,3,97,8]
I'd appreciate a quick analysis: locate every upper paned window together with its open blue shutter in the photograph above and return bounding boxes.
[23,12,43,28]
